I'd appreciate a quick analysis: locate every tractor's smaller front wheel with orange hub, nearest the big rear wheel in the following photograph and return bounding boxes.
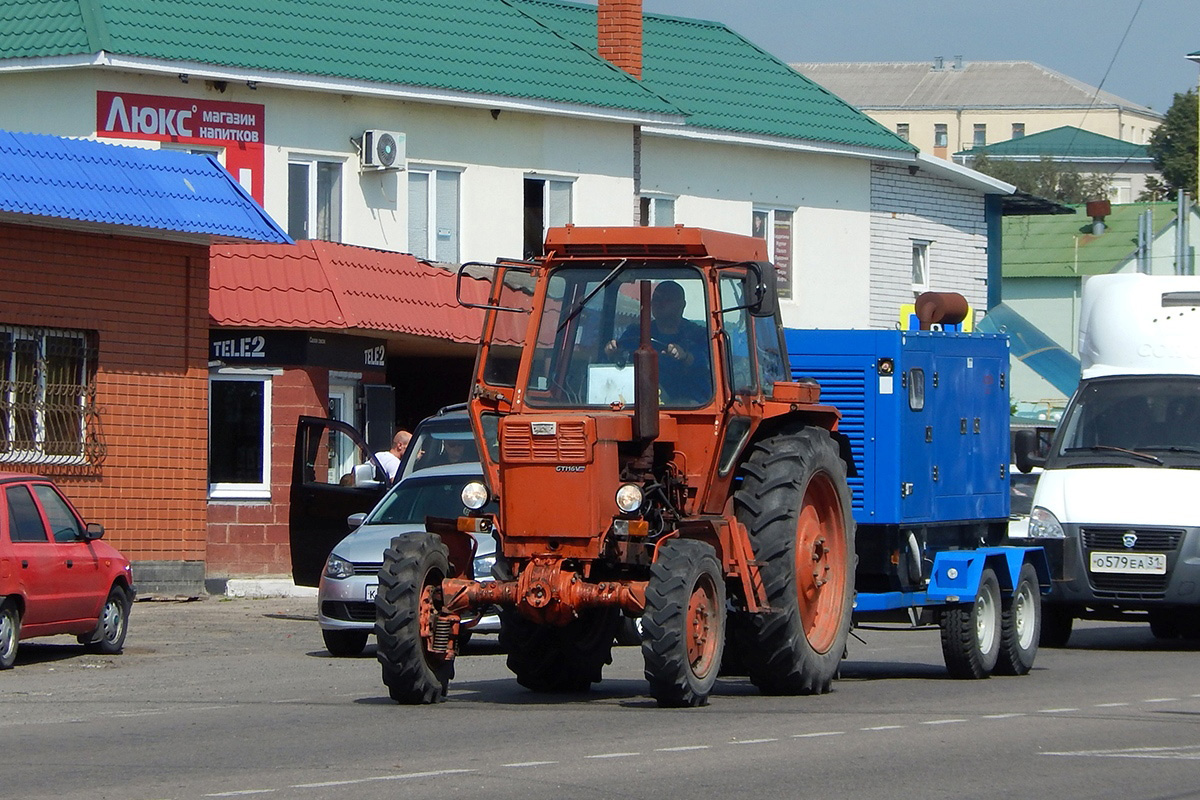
[642,539,725,708]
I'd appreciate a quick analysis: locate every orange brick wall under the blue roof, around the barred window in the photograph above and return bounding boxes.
[0,223,209,561]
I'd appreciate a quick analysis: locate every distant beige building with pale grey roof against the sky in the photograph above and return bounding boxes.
[792,56,1163,158]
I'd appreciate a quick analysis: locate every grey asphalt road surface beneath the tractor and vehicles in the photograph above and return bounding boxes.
[0,600,1200,800]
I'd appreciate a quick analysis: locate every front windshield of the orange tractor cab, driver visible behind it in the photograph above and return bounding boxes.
[526,264,713,408]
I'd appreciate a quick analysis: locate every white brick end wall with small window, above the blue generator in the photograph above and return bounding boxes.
[870,163,988,329]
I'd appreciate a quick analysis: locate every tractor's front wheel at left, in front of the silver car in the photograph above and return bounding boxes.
[374,533,454,705]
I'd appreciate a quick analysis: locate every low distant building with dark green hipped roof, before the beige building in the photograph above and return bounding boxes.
[954,125,1158,203]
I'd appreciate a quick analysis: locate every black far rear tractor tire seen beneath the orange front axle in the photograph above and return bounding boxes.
[499,608,622,693]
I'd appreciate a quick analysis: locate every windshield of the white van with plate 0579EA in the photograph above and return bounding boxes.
[1046,375,1200,469]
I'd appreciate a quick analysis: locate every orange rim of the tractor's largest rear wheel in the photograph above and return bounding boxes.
[796,473,846,652]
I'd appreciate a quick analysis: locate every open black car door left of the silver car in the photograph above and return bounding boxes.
[288,416,388,587]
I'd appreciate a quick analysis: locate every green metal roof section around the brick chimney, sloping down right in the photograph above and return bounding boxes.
[511,0,916,152]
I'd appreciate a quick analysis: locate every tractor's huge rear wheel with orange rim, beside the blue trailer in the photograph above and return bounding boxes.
[731,427,854,694]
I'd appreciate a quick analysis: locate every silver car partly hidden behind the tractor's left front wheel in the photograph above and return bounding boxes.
[317,462,500,656]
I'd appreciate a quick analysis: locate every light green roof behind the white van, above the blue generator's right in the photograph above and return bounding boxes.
[1002,203,1176,278]
